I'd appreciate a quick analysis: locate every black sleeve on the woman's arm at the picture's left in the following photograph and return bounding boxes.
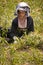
[9,18,17,38]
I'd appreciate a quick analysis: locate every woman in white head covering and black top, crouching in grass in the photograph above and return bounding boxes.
[8,2,34,42]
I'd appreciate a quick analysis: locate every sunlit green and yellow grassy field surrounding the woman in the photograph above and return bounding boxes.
[0,0,43,65]
